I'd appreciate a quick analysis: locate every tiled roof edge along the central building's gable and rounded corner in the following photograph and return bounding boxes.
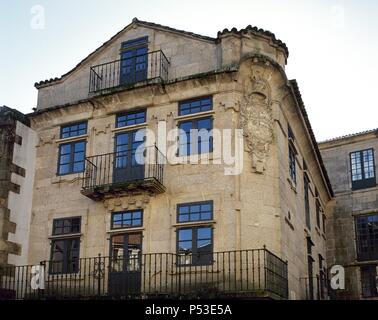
[34,18,289,89]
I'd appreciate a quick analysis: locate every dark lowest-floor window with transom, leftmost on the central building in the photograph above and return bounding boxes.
[49,217,81,274]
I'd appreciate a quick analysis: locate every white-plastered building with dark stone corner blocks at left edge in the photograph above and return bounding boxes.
[0,106,36,266]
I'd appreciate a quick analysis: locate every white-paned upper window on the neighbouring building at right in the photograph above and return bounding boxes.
[350,149,376,189]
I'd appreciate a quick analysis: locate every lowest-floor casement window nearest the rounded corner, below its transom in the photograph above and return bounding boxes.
[177,226,213,265]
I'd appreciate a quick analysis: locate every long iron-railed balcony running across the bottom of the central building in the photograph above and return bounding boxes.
[0,249,288,299]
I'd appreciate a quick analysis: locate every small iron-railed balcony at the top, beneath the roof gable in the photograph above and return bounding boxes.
[89,50,169,94]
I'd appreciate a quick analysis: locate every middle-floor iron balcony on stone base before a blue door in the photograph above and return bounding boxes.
[81,146,166,201]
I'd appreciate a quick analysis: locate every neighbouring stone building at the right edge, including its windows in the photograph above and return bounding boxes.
[319,129,378,299]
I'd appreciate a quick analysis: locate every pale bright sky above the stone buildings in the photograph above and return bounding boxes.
[0,0,378,141]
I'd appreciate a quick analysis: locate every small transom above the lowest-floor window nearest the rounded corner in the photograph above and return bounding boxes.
[177,201,213,222]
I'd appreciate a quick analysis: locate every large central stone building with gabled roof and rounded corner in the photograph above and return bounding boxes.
[0,19,333,299]
